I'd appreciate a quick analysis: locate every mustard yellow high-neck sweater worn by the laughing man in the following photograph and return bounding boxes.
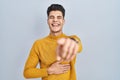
[24,34,82,80]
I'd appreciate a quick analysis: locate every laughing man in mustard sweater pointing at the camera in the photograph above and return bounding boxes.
[24,4,82,80]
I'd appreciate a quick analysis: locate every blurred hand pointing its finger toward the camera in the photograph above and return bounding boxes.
[57,38,78,62]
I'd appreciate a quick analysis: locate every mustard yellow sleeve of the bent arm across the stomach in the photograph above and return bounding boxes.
[23,41,48,78]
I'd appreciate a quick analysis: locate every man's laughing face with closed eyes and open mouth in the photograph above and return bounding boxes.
[48,11,64,33]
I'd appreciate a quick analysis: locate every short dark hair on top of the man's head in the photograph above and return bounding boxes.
[47,4,65,18]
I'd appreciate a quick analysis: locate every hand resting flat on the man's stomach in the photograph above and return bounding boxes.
[47,61,70,74]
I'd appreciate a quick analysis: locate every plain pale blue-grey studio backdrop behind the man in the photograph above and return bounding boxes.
[0,0,120,80]
